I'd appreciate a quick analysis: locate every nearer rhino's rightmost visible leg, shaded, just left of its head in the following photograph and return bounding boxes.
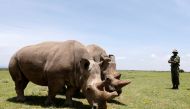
[64,86,77,106]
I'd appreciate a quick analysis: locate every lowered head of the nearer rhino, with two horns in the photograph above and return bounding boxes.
[81,59,118,109]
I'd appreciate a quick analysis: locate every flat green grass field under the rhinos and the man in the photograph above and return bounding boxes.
[0,71,190,109]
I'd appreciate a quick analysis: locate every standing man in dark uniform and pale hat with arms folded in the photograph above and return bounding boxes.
[168,49,180,89]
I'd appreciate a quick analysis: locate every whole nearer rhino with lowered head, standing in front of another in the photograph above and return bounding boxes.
[9,40,118,109]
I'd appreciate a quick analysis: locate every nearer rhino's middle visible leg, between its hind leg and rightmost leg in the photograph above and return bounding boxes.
[45,79,64,105]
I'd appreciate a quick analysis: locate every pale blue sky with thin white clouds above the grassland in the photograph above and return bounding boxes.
[0,0,190,71]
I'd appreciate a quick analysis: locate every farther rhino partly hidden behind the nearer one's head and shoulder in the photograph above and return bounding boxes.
[87,44,130,95]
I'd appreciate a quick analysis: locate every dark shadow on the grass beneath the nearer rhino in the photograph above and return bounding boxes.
[7,96,90,109]
